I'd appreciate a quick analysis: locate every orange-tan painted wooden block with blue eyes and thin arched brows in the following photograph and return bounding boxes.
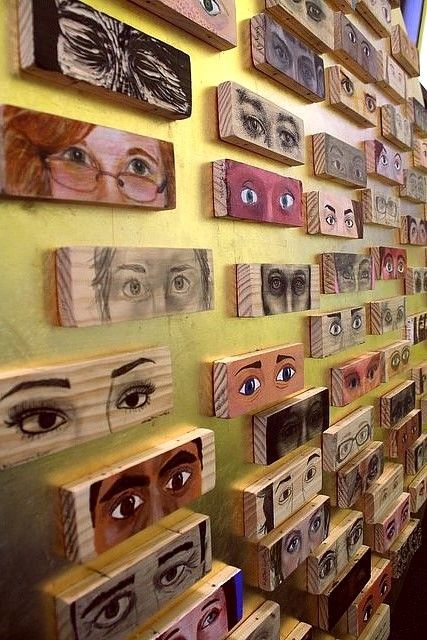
[212,343,304,418]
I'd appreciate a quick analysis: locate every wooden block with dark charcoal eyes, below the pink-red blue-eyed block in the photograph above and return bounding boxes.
[236,264,320,318]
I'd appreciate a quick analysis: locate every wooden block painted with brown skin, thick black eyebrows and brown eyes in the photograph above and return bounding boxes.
[59,429,215,562]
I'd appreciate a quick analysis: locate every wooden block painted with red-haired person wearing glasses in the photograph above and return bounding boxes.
[0,105,176,209]
